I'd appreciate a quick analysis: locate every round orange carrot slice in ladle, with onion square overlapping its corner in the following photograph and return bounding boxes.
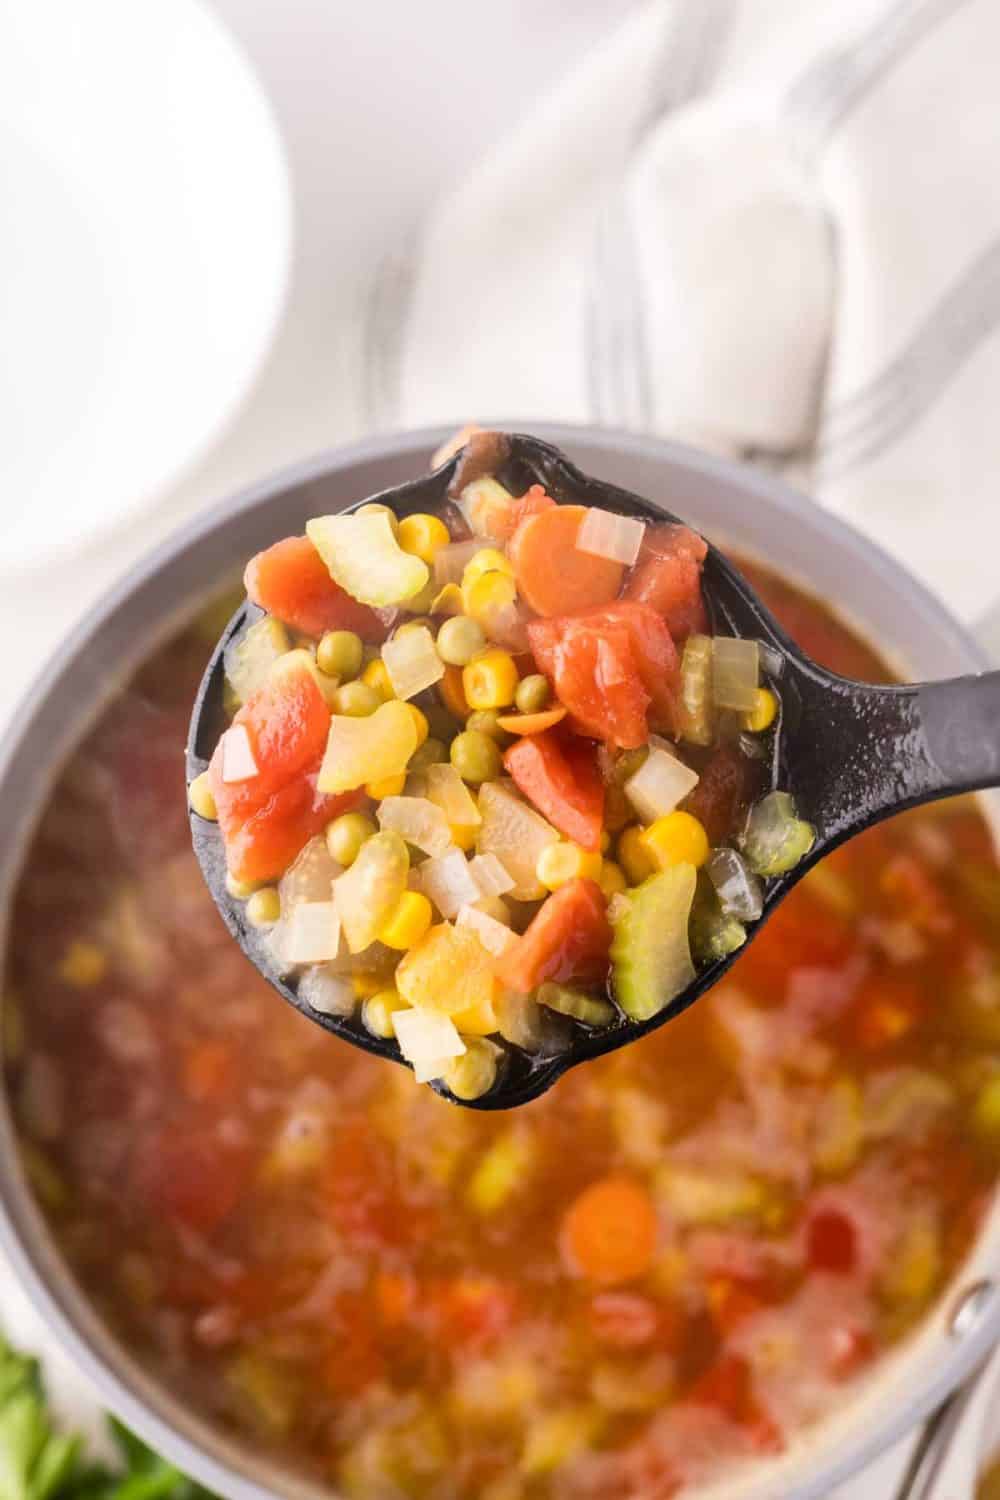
[508,506,625,615]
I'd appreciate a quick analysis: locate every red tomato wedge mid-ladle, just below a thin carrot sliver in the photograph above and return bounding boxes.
[504,729,604,854]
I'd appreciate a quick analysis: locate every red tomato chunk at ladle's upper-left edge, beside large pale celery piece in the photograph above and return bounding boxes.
[243,537,390,645]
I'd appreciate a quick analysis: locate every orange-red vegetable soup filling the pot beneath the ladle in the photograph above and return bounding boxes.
[4,576,1000,1500]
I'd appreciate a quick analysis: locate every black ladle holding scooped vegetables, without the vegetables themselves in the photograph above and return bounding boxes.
[187,435,1000,1110]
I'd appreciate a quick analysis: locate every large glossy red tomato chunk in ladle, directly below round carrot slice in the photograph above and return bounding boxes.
[528,602,678,750]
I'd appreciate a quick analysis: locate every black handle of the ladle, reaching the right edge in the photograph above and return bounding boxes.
[784,672,1000,852]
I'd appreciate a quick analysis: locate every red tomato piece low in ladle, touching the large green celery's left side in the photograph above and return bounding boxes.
[498,879,612,995]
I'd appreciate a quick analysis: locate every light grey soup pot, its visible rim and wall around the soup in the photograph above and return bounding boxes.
[0,426,1000,1500]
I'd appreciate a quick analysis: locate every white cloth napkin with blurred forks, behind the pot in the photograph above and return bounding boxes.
[367,0,1000,620]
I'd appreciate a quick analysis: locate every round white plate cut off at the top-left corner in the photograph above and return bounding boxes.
[0,0,291,569]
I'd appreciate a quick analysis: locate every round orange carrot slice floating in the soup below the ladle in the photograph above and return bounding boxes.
[559,1178,657,1286]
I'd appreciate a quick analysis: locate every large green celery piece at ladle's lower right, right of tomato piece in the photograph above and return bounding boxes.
[612,864,697,1022]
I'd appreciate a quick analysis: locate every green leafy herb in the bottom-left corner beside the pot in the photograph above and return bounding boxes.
[0,1338,214,1500]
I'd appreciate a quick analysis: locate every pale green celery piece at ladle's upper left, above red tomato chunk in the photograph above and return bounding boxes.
[306,512,430,609]
